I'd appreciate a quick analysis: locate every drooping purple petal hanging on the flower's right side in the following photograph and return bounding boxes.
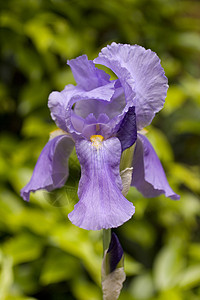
[132,134,180,200]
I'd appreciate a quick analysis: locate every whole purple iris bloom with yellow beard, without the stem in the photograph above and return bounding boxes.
[21,43,179,230]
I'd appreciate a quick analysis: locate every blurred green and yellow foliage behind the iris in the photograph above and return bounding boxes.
[0,0,200,300]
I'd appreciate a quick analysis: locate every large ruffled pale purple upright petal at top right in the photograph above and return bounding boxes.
[94,43,168,130]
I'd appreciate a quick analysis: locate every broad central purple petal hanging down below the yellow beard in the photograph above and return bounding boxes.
[68,136,134,230]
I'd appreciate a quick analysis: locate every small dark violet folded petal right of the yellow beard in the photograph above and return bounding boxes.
[117,107,137,151]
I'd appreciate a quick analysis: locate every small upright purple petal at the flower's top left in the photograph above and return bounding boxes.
[68,55,110,91]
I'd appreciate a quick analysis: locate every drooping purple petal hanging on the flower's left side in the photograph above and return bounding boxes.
[21,134,74,201]
